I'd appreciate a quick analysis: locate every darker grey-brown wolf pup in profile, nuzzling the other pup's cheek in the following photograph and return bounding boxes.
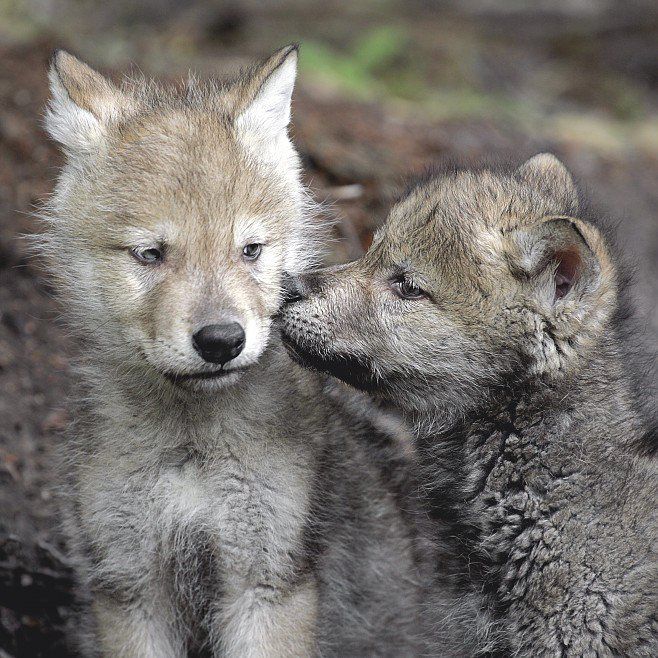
[283,154,658,657]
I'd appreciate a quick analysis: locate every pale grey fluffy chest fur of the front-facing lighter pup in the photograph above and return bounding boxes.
[72,404,313,619]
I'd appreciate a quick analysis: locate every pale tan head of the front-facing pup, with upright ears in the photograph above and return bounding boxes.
[43,46,315,390]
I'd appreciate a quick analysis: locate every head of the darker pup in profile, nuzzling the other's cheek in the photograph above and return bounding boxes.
[283,154,616,413]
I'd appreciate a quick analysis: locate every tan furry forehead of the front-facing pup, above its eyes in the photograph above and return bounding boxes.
[103,109,290,229]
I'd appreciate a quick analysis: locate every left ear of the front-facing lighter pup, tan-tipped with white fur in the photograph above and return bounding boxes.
[45,50,133,154]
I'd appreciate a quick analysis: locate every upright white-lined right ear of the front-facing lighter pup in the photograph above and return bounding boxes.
[235,45,298,142]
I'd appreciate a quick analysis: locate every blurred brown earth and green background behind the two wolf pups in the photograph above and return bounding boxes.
[0,0,658,657]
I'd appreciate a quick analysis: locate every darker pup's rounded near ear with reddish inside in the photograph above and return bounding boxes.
[507,217,617,373]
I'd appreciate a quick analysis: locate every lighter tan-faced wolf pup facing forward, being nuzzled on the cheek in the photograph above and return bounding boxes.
[42,47,422,658]
